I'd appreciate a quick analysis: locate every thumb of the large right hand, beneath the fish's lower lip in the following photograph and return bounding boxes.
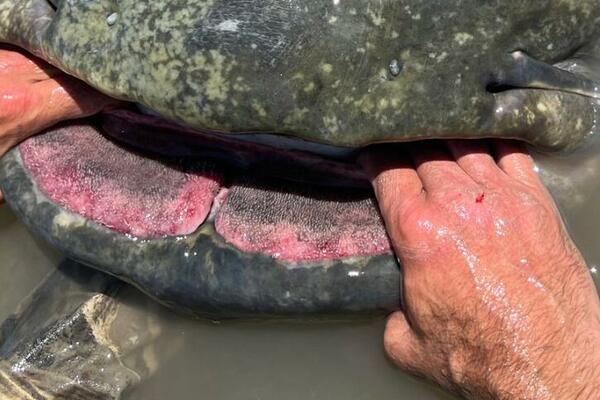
[383,311,423,374]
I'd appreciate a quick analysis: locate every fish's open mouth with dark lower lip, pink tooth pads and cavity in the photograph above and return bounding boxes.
[0,114,400,318]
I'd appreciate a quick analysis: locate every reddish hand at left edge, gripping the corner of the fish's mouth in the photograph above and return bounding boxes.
[0,47,118,200]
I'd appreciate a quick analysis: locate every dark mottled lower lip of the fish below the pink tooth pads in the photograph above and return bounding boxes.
[0,144,400,319]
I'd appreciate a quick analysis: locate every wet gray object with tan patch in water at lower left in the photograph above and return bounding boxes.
[0,261,160,400]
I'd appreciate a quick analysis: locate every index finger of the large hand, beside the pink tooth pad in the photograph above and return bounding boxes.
[358,146,423,221]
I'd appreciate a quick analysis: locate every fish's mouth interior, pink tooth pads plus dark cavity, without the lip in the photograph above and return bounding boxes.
[20,112,390,261]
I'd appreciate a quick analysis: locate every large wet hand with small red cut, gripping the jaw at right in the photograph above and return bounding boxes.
[360,141,600,399]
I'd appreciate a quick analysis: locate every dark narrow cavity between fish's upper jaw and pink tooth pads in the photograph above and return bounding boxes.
[99,110,370,188]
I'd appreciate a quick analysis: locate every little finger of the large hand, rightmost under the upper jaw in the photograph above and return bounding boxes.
[493,140,543,187]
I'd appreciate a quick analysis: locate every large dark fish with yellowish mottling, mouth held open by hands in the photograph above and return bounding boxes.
[0,0,600,316]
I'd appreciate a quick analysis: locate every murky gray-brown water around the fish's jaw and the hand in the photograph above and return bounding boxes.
[0,137,600,400]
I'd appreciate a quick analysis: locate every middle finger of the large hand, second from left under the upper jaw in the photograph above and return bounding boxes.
[409,142,475,193]
